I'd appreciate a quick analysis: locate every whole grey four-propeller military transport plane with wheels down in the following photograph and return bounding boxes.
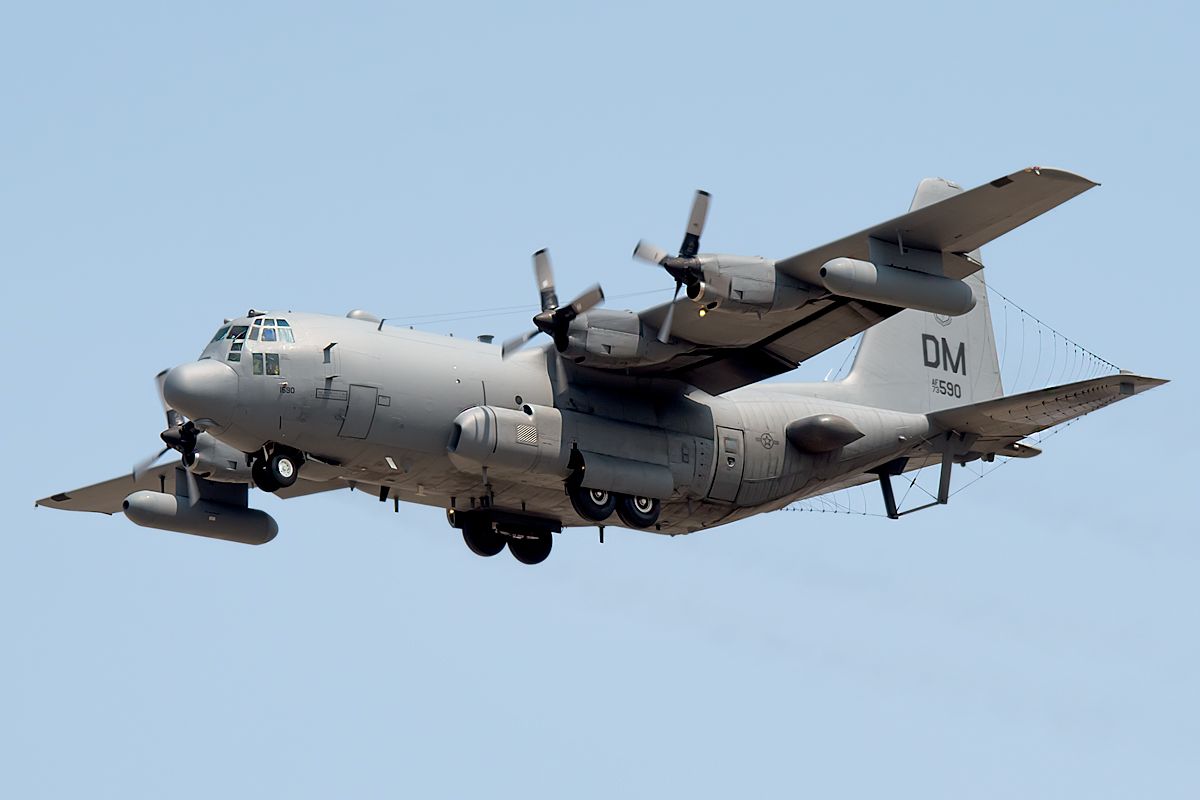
[37,167,1165,564]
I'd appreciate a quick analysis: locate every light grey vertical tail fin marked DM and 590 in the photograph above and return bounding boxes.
[841,178,1004,414]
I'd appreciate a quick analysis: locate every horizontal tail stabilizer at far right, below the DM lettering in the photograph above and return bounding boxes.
[929,373,1166,441]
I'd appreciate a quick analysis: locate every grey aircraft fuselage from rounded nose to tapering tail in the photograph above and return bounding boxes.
[167,313,929,534]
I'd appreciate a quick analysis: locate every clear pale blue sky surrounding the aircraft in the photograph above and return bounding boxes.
[0,2,1200,798]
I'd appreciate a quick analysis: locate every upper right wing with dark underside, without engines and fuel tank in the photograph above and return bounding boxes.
[630,167,1097,395]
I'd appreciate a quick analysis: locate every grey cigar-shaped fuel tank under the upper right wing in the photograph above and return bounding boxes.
[820,258,974,317]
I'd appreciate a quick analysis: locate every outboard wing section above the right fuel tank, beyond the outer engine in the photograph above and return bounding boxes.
[776,167,1098,284]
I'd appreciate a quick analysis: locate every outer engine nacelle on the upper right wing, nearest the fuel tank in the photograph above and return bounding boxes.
[688,255,812,313]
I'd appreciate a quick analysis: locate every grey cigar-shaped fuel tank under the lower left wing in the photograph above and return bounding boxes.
[122,492,280,545]
